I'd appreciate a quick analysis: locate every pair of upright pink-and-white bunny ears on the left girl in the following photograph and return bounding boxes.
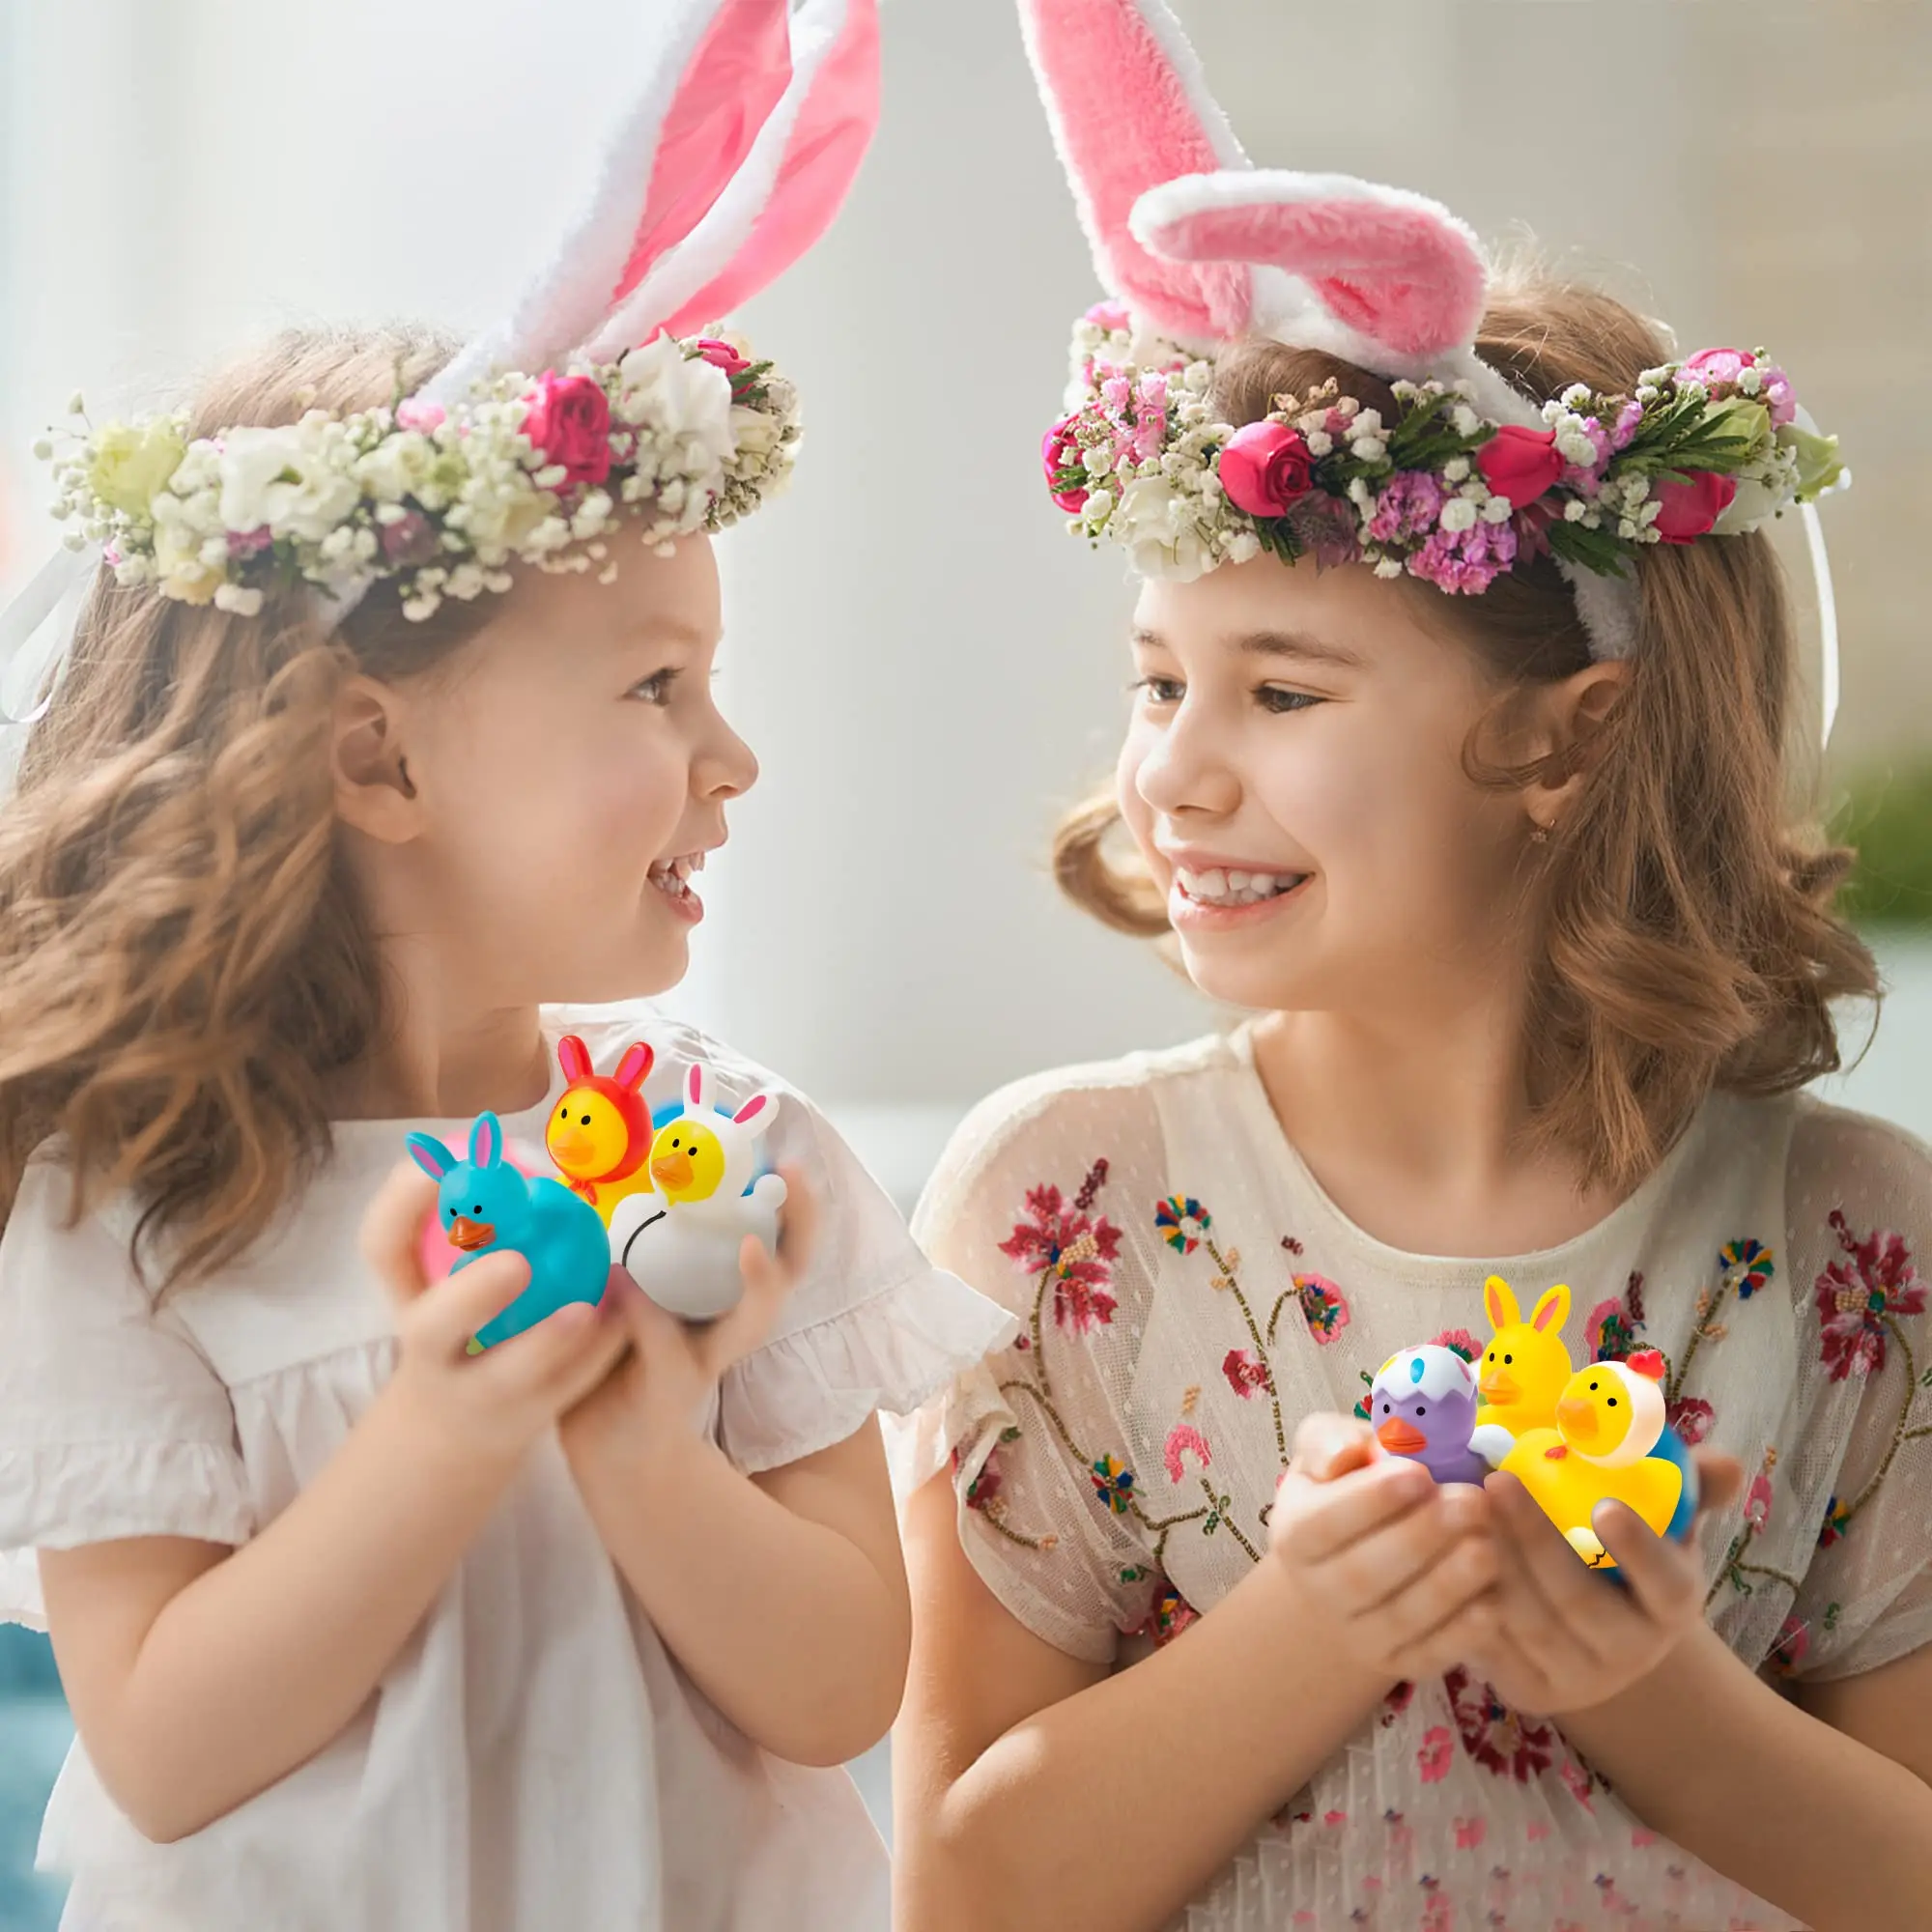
[417,0,879,406]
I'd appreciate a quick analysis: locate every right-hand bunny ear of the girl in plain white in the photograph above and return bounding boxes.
[583,0,879,359]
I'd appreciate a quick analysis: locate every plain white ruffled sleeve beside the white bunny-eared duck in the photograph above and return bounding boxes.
[711,1074,1014,1474]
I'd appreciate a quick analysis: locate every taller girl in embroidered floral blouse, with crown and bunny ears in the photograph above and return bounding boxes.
[895,0,1932,1932]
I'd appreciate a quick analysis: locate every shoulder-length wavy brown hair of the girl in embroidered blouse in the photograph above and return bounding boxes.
[1053,269,1878,1190]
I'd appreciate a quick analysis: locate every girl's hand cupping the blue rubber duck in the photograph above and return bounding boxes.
[361,1161,626,1461]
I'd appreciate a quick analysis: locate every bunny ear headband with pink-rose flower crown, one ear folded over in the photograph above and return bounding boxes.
[1020,0,1845,734]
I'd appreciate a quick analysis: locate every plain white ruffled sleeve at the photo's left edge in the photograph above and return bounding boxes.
[0,1155,255,1629]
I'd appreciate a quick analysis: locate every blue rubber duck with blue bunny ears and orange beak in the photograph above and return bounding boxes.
[408,1113,611,1354]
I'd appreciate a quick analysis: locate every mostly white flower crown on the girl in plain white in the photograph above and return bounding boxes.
[37,334,800,620]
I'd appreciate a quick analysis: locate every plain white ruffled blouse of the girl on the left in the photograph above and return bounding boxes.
[0,1007,1010,1932]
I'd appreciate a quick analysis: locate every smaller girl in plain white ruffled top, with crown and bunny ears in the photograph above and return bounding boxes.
[0,0,1007,1932]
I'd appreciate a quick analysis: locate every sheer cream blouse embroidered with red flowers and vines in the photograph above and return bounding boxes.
[895,1032,1932,1932]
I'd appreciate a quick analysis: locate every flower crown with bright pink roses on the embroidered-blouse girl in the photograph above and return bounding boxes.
[1041,303,1843,595]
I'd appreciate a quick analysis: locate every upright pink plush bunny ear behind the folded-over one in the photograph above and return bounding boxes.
[1020,0,1254,346]
